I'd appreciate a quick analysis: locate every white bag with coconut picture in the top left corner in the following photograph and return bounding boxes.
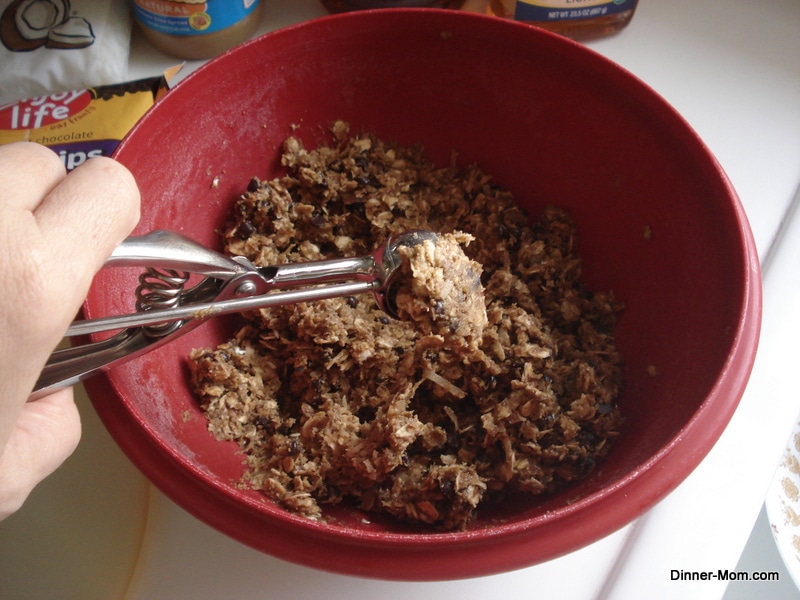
[0,0,131,105]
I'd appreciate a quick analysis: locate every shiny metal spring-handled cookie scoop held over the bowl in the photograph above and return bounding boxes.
[33,231,438,397]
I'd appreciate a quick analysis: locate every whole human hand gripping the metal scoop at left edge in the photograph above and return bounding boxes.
[0,142,139,519]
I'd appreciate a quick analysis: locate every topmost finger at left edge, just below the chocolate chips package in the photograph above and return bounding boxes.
[0,142,66,211]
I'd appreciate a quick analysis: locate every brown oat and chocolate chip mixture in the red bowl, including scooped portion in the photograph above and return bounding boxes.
[190,122,621,530]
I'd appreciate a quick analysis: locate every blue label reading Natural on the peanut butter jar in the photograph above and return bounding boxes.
[133,0,260,36]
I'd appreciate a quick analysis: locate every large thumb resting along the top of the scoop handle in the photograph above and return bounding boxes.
[0,158,139,424]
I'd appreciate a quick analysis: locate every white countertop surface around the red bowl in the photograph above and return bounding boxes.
[0,0,800,600]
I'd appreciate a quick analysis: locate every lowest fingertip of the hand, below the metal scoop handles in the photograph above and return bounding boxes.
[0,389,81,520]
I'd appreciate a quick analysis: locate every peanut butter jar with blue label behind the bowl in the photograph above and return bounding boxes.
[132,0,263,60]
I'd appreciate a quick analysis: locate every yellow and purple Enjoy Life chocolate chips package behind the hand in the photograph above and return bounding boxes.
[0,70,174,171]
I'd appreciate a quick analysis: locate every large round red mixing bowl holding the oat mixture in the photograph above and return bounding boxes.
[85,9,761,580]
